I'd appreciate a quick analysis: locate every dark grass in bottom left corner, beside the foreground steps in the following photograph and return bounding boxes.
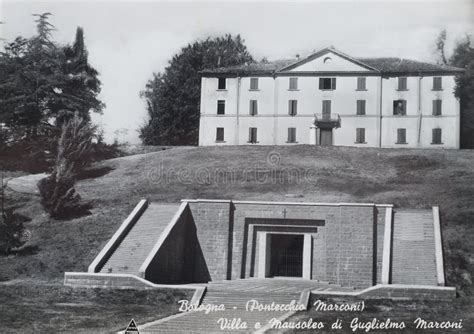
[0,280,192,333]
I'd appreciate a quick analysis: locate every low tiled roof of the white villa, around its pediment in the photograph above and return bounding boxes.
[201,48,464,76]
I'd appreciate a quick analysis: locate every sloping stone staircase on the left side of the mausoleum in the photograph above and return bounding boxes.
[100,203,179,275]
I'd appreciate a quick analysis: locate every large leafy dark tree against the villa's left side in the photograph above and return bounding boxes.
[140,34,253,145]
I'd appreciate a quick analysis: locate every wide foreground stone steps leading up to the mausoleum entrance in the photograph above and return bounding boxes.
[141,279,342,333]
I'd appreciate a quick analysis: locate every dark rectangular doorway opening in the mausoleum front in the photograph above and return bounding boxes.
[270,234,304,277]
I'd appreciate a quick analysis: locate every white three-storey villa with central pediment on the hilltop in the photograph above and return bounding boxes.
[199,48,463,148]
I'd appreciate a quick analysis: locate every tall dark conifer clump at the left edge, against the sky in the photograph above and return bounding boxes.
[0,13,104,140]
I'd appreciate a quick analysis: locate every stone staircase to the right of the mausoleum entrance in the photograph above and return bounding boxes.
[392,210,437,286]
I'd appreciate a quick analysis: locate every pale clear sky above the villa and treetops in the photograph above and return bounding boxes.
[0,0,474,144]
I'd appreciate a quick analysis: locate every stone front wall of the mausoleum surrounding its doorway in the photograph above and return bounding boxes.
[189,201,384,288]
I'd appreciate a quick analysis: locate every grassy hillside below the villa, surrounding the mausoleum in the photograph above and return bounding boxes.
[0,145,474,329]
